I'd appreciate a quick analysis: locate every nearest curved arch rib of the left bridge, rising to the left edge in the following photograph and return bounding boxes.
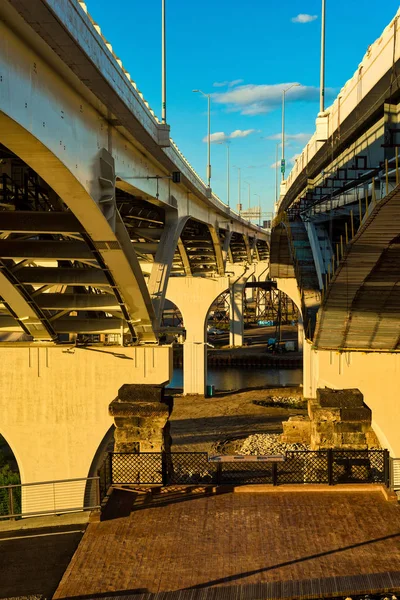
[0,111,156,341]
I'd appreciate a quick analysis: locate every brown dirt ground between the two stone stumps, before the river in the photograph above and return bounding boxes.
[170,388,307,454]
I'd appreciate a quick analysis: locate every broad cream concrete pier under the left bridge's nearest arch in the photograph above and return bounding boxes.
[0,344,172,511]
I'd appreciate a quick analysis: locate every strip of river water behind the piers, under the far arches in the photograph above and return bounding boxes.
[168,367,303,390]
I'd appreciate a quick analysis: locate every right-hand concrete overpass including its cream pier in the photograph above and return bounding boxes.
[271,12,400,456]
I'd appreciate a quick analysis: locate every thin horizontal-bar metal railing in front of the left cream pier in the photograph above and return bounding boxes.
[0,477,101,520]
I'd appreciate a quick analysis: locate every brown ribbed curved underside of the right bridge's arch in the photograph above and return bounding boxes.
[315,186,400,350]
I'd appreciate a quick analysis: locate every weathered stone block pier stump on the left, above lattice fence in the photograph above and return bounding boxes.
[109,384,172,453]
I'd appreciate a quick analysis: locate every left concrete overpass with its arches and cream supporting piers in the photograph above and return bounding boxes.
[0,0,269,496]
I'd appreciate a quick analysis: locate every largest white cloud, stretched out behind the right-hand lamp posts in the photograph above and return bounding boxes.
[212,82,333,115]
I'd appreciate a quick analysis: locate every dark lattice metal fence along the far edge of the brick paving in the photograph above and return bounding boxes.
[99,449,390,499]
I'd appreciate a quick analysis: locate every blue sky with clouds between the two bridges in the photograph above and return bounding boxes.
[86,0,399,216]
